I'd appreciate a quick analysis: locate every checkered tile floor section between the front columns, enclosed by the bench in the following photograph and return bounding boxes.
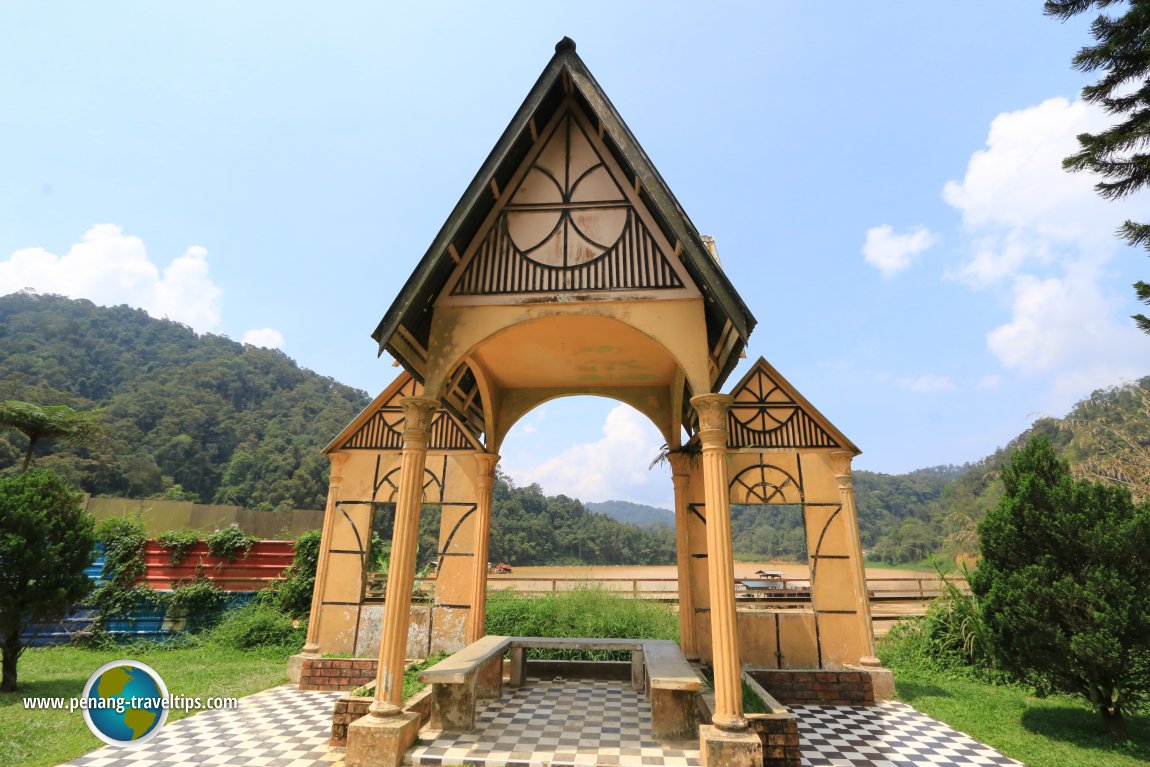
[405,680,699,767]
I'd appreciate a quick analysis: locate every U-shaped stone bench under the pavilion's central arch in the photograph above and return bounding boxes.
[420,636,703,741]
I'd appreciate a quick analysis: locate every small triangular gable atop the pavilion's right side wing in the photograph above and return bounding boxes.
[727,356,861,455]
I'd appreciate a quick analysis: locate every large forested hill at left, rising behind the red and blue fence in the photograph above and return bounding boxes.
[0,293,370,508]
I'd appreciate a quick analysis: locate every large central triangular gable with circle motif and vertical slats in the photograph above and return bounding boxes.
[439,99,699,296]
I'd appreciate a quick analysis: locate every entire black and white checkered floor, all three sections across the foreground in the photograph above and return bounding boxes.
[56,680,1020,767]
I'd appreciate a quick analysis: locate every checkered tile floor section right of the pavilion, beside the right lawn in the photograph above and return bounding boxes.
[790,701,1022,767]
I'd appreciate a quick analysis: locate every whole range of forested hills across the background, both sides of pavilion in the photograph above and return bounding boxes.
[0,293,1150,563]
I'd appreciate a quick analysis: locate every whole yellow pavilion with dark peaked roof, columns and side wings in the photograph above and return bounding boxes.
[292,38,889,765]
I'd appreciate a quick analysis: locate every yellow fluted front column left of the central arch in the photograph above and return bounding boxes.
[369,397,439,716]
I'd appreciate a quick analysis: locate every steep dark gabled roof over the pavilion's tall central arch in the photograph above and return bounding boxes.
[371,37,756,390]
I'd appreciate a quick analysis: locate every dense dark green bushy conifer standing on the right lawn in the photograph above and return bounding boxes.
[971,437,1150,738]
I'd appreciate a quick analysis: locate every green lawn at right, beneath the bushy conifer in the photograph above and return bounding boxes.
[895,667,1150,767]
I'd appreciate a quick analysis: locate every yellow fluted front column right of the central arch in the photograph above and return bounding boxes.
[691,394,746,730]
